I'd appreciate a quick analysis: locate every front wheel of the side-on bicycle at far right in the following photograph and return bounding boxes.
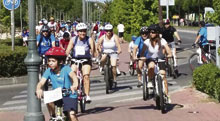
[188,53,201,71]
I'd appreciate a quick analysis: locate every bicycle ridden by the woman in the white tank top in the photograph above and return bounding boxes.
[103,52,117,94]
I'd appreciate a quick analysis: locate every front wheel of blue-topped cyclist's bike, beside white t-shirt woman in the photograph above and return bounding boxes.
[142,70,149,101]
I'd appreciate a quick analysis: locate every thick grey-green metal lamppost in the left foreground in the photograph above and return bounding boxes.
[24,0,45,121]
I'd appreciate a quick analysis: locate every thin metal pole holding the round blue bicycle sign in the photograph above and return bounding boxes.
[11,0,15,51]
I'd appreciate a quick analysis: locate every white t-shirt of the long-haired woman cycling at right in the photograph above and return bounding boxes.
[144,38,167,59]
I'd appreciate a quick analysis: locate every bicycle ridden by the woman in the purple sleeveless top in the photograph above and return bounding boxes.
[71,59,88,113]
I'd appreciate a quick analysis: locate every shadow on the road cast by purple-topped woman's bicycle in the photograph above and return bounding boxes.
[77,107,115,117]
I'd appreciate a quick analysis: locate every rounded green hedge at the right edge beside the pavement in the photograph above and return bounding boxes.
[193,64,220,101]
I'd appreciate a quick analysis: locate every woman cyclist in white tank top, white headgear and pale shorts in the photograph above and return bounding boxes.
[98,24,121,87]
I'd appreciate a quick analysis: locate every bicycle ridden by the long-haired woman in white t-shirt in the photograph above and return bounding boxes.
[149,58,168,113]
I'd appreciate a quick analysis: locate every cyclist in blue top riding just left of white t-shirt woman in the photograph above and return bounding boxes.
[132,26,149,87]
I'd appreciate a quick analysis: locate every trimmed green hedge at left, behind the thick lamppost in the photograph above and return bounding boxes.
[0,38,27,77]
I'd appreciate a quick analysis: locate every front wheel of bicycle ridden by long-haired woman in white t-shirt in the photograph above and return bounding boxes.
[157,75,165,113]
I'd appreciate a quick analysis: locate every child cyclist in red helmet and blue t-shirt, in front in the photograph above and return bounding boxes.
[36,47,78,121]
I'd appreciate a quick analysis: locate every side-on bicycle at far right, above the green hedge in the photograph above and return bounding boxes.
[188,43,216,71]
